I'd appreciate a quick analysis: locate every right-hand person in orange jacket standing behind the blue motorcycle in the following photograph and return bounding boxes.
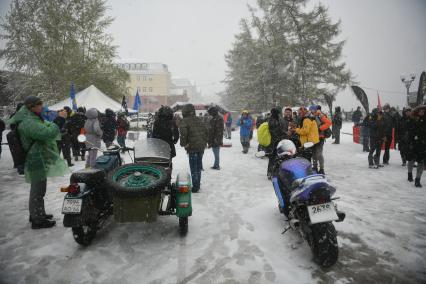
[309,106,331,174]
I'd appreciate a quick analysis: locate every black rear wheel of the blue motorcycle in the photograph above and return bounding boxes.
[310,223,339,267]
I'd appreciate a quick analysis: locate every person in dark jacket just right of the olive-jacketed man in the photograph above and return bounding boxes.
[208,107,224,170]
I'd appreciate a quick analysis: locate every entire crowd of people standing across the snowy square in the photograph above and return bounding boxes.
[0,96,426,229]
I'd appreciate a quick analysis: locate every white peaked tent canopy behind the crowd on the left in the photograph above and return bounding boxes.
[49,85,122,112]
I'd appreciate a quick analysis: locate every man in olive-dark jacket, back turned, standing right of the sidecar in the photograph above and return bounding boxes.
[179,104,208,192]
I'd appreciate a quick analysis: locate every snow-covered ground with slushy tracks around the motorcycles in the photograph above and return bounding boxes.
[0,124,426,284]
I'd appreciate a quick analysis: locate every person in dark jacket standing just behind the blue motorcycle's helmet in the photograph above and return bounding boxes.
[266,107,288,179]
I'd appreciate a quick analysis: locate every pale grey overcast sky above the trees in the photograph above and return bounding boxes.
[0,0,426,109]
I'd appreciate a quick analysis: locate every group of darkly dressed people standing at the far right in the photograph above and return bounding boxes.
[353,104,426,187]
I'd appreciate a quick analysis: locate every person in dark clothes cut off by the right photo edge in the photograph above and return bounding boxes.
[407,105,426,187]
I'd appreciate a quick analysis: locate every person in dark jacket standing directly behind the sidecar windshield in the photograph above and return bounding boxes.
[152,106,179,158]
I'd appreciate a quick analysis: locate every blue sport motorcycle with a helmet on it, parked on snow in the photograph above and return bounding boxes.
[272,140,345,267]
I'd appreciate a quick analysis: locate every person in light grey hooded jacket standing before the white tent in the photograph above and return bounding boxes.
[84,108,103,168]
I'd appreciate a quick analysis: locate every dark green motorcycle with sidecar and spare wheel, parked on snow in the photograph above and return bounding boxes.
[61,136,192,246]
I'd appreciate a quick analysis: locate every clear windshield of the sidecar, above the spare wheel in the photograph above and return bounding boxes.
[135,138,170,163]
